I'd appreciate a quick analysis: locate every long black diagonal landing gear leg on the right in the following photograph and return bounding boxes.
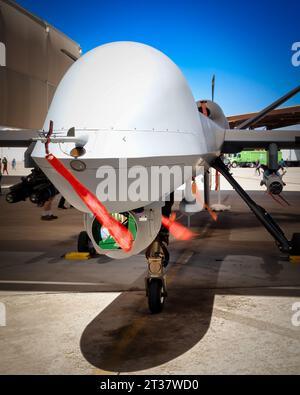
[212,158,300,255]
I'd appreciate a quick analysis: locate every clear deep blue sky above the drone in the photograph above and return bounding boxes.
[17,0,300,115]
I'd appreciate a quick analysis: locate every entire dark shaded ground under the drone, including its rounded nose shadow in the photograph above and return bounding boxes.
[0,194,300,372]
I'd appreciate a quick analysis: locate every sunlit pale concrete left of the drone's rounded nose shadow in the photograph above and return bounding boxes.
[0,293,118,374]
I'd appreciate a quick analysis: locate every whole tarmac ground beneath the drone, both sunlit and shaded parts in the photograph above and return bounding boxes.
[0,186,300,374]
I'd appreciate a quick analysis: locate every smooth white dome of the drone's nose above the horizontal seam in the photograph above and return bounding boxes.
[44,42,199,132]
